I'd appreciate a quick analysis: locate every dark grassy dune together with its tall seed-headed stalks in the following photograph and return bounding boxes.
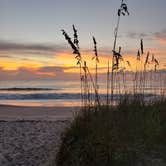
[56,0,166,166]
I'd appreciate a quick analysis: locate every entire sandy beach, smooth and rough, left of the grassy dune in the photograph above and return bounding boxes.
[0,105,78,166]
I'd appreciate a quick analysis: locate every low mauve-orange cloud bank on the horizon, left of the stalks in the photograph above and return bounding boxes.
[0,66,79,80]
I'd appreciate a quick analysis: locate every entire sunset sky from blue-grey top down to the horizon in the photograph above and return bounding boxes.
[0,0,166,80]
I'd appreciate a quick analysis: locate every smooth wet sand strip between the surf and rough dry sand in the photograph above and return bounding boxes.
[0,105,79,121]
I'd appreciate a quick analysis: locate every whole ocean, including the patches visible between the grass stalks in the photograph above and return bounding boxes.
[0,72,166,107]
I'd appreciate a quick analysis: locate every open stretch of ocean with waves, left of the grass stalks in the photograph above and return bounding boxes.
[0,80,80,106]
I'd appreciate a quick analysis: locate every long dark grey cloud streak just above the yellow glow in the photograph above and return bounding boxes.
[0,40,112,60]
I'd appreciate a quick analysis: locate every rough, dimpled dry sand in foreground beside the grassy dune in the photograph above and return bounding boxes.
[0,121,69,166]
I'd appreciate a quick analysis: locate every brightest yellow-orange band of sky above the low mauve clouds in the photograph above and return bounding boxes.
[0,49,166,70]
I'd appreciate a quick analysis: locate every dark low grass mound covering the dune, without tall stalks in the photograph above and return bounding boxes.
[56,97,166,166]
